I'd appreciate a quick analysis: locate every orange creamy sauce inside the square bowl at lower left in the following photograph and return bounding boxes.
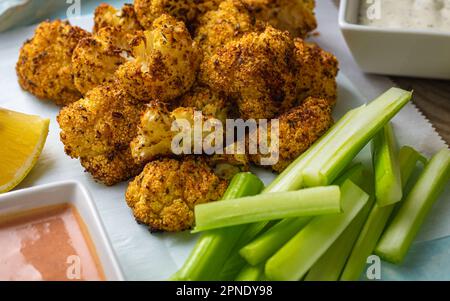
[0,204,104,281]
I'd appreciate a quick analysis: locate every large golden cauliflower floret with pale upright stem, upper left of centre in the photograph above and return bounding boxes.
[116,15,200,102]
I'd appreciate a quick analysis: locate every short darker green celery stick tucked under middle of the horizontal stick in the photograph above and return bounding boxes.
[239,217,312,265]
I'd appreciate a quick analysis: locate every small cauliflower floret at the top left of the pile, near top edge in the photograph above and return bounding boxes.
[94,3,142,37]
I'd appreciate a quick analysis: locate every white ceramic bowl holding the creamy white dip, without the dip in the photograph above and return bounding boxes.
[339,0,450,79]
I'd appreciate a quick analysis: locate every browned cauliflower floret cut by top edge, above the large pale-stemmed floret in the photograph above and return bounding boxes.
[134,0,222,29]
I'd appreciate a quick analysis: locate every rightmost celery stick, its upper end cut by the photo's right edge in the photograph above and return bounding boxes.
[375,149,450,263]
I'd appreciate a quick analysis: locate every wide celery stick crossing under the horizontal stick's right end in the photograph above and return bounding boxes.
[265,181,369,281]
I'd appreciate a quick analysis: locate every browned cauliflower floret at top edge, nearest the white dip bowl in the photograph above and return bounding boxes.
[242,0,317,37]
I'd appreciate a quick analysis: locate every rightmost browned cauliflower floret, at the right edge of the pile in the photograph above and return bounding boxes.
[295,39,339,105]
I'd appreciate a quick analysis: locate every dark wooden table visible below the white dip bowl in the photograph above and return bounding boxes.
[333,0,450,145]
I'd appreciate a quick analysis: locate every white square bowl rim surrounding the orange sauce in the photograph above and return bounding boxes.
[0,181,124,281]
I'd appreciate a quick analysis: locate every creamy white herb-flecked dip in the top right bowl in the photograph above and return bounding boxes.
[359,0,450,32]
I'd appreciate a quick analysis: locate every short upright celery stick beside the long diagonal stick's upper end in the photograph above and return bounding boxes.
[372,124,403,207]
